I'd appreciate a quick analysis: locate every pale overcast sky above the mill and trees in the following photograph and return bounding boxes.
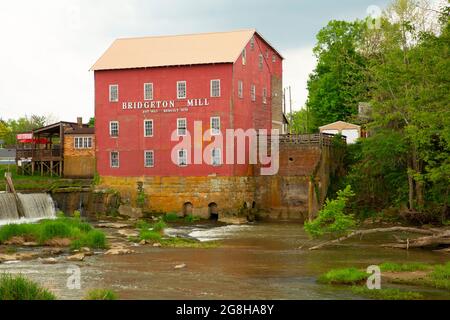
[0,0,388,121]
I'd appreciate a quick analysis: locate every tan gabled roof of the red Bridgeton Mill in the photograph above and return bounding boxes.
[90,29,282,71]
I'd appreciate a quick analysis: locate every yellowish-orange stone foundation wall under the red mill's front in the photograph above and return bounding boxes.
[99,177,255,218]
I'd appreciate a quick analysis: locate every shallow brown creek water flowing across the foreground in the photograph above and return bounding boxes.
[0,223,450,299]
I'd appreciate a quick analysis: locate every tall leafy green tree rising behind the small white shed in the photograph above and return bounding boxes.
[307,21,368,128]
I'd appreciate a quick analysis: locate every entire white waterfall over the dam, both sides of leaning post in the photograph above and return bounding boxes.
[0,193,56,225]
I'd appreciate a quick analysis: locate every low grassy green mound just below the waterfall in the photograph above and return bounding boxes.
[0,216,107,249]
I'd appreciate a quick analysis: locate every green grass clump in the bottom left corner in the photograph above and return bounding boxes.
[0,274,55,300]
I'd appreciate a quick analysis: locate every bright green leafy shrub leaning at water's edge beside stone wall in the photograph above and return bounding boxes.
[304,186,356,238]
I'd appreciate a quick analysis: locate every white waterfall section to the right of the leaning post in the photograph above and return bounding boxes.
[18,193,55,219]
